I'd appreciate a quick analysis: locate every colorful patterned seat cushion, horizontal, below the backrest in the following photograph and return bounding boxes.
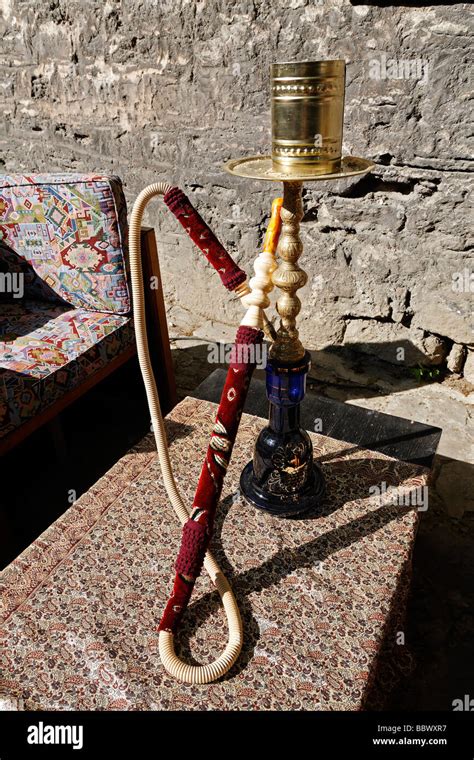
[0,300,134,438]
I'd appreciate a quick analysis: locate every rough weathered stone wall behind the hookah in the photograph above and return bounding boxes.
[0,0,474,381]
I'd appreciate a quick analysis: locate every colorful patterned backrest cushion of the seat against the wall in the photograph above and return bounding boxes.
[0,174,130,314]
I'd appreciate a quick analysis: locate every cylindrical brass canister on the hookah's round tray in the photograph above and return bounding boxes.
[271,60,346,174]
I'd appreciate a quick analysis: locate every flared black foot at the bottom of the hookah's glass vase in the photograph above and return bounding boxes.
[240,460,326,517]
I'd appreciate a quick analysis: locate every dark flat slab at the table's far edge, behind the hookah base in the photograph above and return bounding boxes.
[192,369,442,467]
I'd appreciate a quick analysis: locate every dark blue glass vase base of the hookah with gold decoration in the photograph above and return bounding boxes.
[240,352,325,517]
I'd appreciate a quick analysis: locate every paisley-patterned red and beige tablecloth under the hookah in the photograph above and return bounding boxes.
[0,398,427,710]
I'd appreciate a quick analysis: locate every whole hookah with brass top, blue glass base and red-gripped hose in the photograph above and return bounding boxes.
[129,60,373,684]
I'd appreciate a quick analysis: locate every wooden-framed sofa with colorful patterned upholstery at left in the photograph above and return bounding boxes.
[0,174,175,453]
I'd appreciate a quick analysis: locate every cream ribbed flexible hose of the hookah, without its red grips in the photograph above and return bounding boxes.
[129,182,243,684]
